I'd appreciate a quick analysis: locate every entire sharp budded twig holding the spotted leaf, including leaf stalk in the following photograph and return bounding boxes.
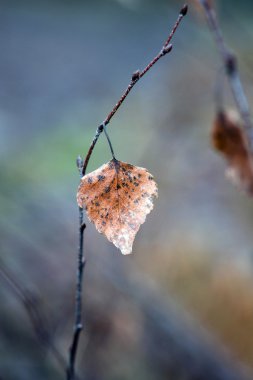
[67,5,188,380]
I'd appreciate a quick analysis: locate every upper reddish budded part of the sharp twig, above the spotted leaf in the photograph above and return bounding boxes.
[82,4,188,175]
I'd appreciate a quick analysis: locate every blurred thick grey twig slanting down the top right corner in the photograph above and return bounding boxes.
[199,0,253,153]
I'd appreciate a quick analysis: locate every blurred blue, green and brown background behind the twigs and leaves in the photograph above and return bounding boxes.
[0,0,253,380]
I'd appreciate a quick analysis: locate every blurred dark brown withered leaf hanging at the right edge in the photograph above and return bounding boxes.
[211,112,253,196]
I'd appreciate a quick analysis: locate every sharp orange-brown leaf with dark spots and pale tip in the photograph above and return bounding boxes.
[77,159,158,255]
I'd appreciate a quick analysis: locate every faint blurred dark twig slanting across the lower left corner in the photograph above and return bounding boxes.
[0,263,66,370]
